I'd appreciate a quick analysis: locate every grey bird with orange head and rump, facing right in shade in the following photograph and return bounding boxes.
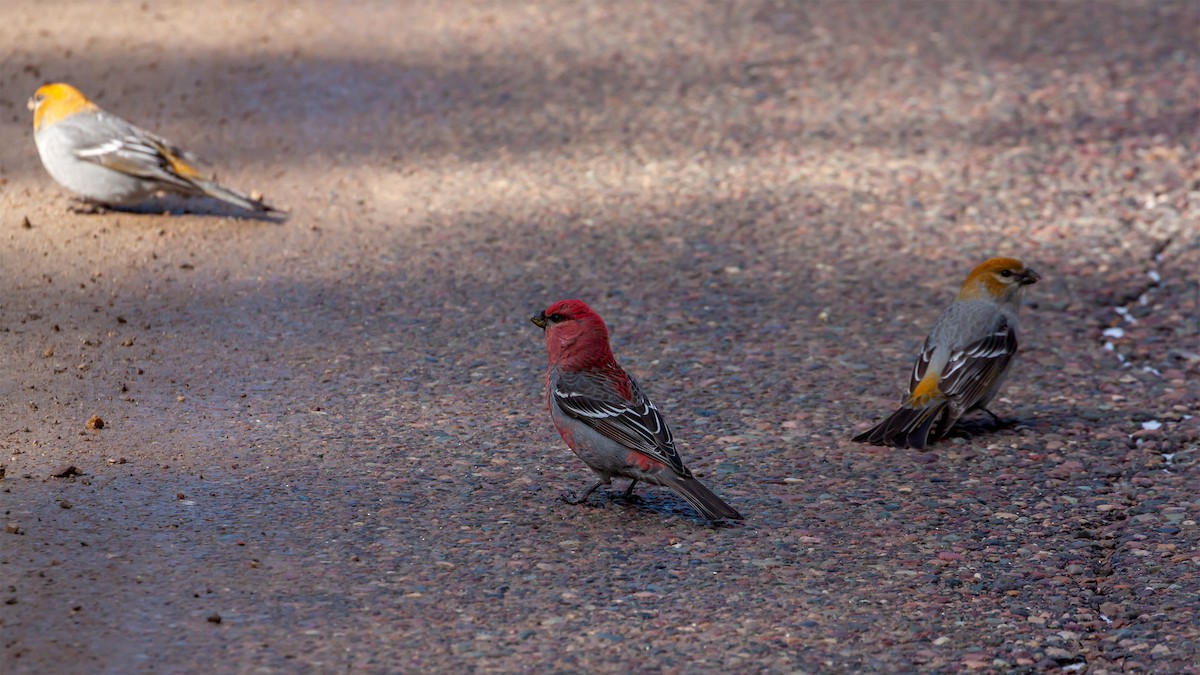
[854,258,1040,449]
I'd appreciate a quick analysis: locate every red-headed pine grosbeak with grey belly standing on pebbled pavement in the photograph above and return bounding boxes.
[532,300,742,521]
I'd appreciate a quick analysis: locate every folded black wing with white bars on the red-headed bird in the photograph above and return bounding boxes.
[552,372,686,474]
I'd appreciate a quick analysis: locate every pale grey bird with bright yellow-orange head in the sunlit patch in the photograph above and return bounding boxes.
[28,83,277,214]
